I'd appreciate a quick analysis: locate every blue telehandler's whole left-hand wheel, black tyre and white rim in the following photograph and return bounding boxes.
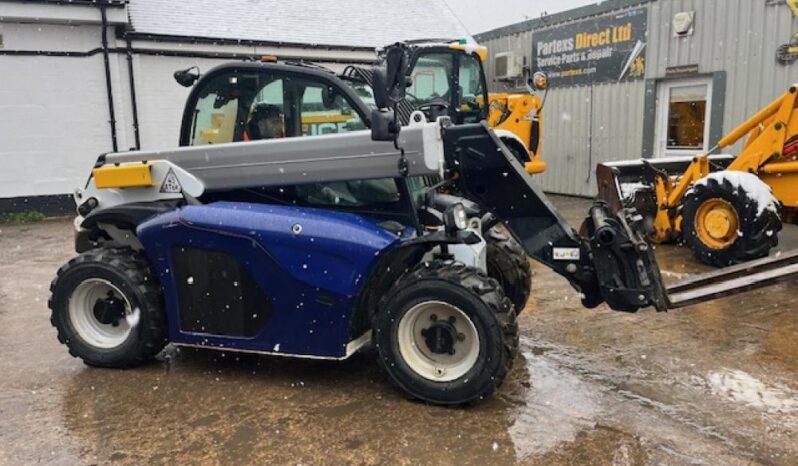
[48,248,167,367]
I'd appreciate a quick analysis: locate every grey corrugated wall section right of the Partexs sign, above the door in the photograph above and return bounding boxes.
[647,0,798,149]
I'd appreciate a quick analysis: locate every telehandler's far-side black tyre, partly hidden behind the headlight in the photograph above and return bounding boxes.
[485,226,532,315]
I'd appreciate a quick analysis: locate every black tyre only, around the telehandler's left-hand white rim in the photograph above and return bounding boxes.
[48,248,167,368]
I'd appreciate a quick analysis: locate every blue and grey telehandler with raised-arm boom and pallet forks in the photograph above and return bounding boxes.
[49,44,798,404]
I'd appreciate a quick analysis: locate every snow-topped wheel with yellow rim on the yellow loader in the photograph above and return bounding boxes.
[682,171,781,267]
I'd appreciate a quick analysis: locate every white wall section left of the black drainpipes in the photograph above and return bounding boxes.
[0,23,117,197]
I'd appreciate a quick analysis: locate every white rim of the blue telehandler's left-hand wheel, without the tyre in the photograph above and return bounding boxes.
[69,278,132,349]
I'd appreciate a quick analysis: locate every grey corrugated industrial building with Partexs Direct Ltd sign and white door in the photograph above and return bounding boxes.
[475,0,798,196]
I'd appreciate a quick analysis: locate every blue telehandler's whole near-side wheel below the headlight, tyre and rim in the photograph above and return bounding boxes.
[373,261,518,405]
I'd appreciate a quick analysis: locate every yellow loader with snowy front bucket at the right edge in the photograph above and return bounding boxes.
[596,85,798,267]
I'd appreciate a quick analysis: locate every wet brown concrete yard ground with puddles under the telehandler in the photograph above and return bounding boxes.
[0,198,798,465]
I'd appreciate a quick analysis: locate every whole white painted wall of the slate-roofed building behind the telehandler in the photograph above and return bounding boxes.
[0,15,374,198]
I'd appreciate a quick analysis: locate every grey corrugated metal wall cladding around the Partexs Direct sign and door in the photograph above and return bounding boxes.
[477,0,798,196]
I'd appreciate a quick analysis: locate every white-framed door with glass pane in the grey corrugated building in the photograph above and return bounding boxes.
[655,78,712,157]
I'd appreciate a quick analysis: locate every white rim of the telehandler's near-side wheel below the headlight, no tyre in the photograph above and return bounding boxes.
[397,301,479,382]
